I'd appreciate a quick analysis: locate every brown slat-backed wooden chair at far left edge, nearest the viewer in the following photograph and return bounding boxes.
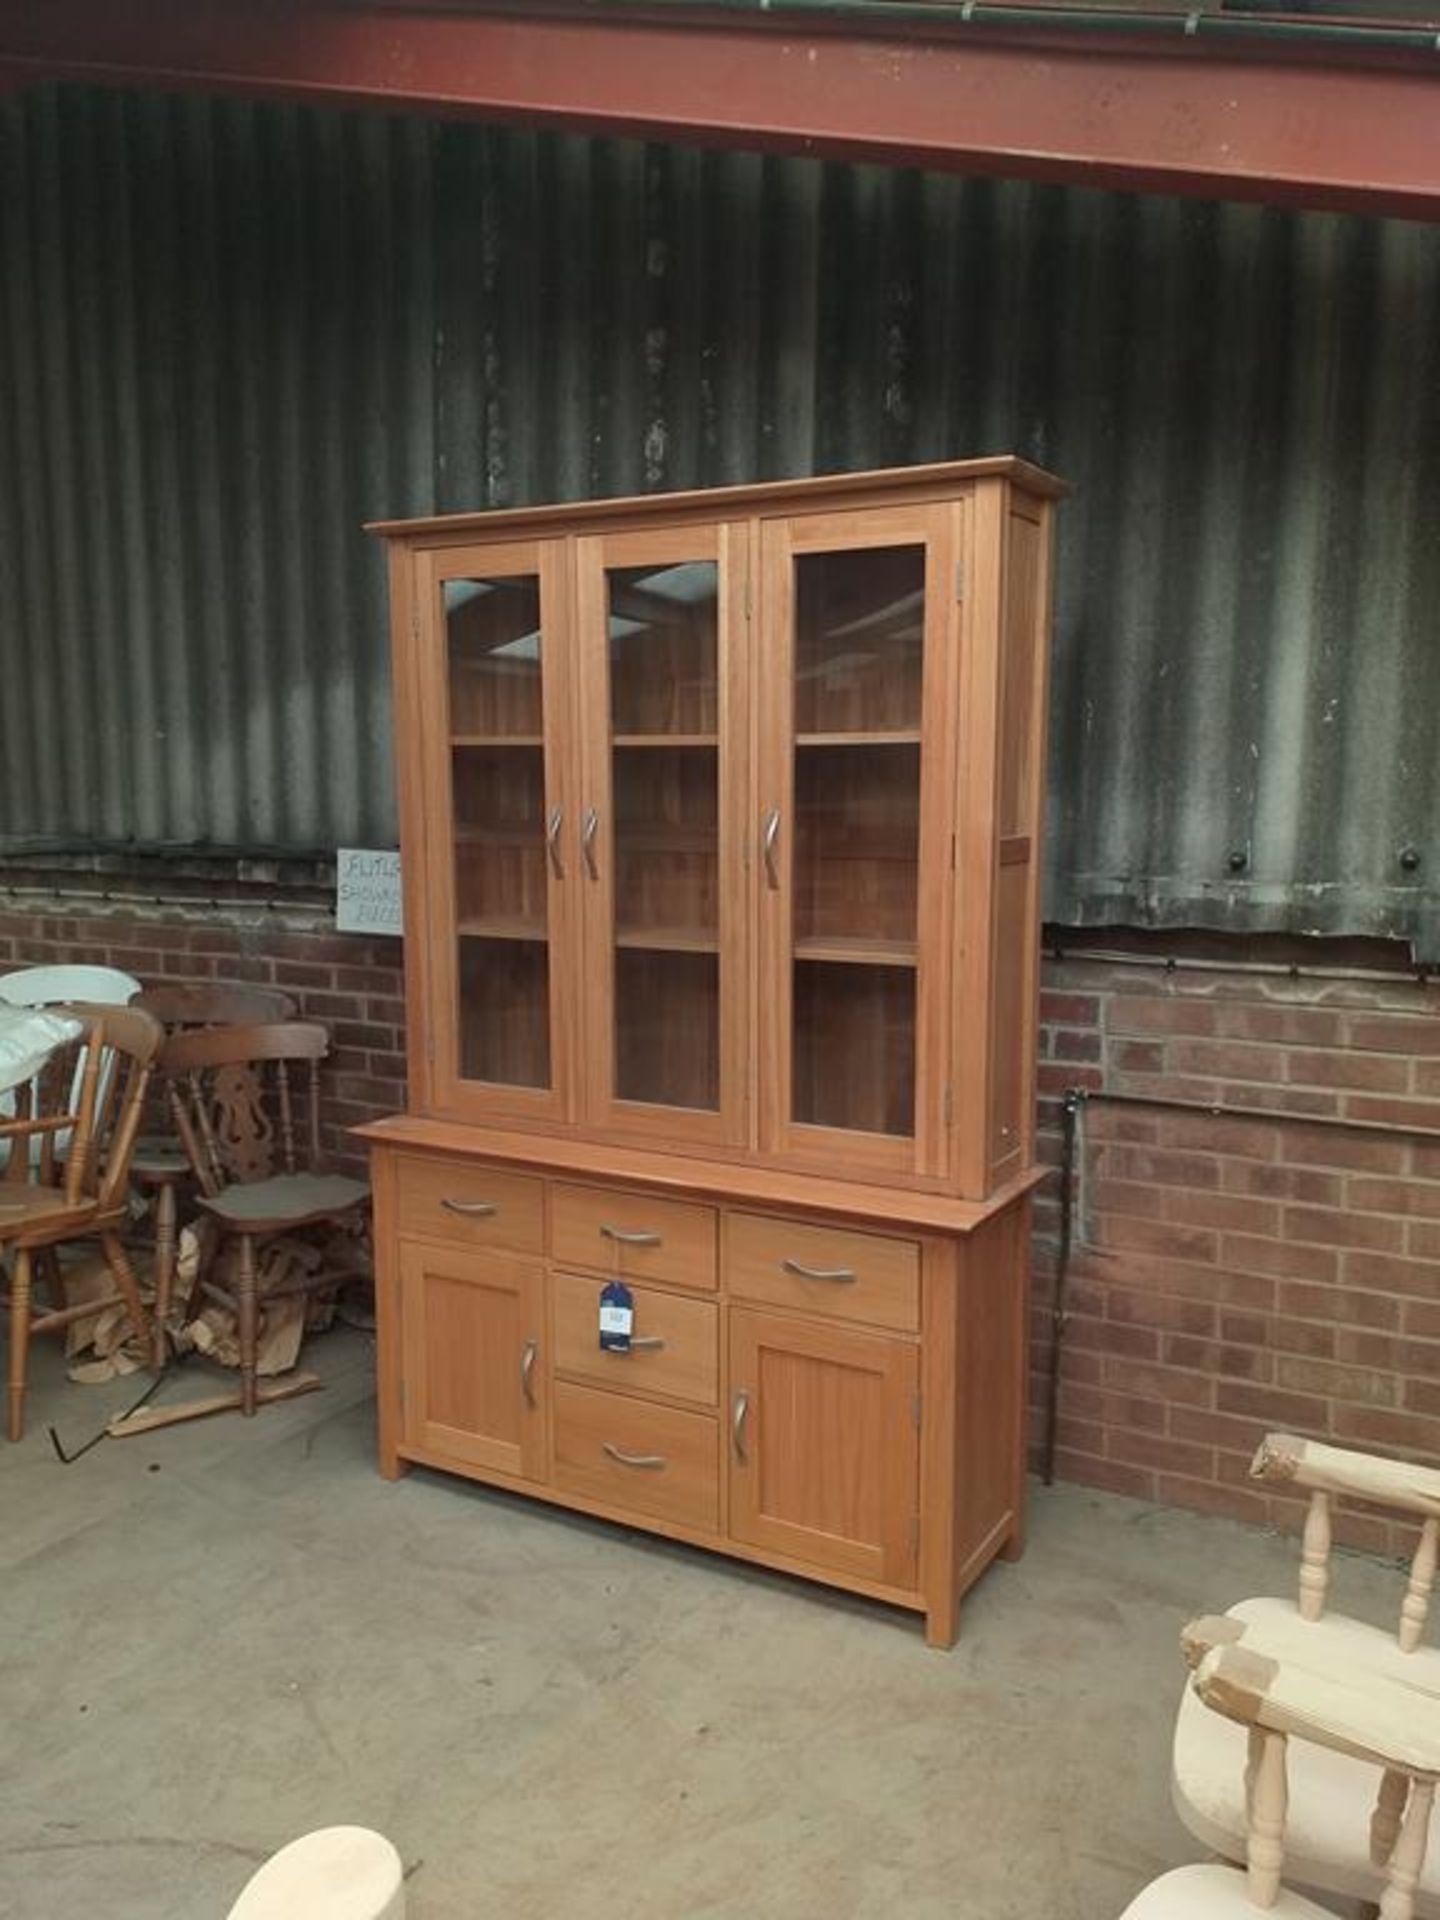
[0,1006,161,1440]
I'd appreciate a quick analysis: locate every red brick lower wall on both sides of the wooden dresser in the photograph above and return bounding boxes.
[0,902,1440,1548]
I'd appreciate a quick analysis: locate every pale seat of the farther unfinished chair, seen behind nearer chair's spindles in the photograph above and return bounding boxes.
[1158,1599,1440,1920]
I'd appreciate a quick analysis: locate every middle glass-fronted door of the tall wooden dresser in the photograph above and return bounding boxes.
[576,524,749,1146]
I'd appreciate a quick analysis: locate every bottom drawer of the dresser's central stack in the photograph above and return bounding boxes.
[553,1380,720,1534]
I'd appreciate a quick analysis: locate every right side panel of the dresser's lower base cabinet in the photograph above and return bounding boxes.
[954,1200,1029,1594]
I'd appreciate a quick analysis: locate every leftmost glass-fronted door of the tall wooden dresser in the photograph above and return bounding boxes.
[405,541,578,1121]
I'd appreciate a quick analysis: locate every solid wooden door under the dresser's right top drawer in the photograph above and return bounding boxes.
[730,1308,920,1590]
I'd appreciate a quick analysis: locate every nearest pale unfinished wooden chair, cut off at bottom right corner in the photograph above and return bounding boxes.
[1121,1615,1440,1920]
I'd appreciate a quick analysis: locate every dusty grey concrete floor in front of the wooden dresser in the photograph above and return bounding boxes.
[0,1331,1394,1920]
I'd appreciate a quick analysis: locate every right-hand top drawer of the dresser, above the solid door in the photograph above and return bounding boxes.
[726,1213,920,1332]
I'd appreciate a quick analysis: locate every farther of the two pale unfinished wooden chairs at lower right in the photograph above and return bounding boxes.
[1171,1434,1440,1920]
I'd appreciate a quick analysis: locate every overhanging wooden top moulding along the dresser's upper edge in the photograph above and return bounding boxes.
[367,453,1069,541]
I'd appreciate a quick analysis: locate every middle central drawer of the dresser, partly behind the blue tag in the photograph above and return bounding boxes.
[553,1273,720,1407]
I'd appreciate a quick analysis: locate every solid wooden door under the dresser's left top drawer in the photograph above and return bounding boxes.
[399,1240,549,1480]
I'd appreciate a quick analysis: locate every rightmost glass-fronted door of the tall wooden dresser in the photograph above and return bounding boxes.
[753,505,960,1179]
